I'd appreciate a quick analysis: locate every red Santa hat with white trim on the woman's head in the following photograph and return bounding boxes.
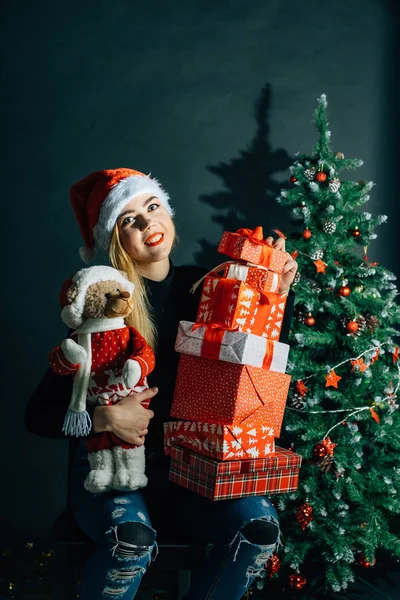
[70,169,174,263]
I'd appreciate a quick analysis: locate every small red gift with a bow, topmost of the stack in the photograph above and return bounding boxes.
[218,227,290,273]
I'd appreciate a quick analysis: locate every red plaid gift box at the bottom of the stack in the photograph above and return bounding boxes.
[169,445,301,500]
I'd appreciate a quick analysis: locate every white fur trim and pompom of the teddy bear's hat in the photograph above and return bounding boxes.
[61,265,135,329]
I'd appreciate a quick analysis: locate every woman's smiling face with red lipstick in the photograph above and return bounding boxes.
[117,194,175,264]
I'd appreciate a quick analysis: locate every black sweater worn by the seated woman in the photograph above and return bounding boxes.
[25,263,294,452]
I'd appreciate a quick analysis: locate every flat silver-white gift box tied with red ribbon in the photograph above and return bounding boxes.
[175,321,290,373]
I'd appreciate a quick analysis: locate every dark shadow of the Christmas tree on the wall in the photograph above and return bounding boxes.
[195,84,293,268]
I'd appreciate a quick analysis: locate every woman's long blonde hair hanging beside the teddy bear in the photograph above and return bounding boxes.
[108,224,157,349]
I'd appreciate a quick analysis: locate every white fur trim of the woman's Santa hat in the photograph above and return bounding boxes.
[93,175,174,250]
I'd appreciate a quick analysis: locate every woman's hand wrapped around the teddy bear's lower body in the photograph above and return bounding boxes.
[93,388,158,446]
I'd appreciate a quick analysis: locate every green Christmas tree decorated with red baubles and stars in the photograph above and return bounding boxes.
[267,95,400,592]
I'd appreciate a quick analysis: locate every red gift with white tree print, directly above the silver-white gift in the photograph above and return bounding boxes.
[196,276,287,340]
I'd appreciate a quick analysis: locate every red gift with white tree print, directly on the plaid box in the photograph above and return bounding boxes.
[164,407,275,460]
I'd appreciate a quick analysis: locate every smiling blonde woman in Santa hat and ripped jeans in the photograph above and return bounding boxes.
[26,169,297,600]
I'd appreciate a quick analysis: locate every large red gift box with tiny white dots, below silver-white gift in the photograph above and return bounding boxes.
[171,354,290,437]
